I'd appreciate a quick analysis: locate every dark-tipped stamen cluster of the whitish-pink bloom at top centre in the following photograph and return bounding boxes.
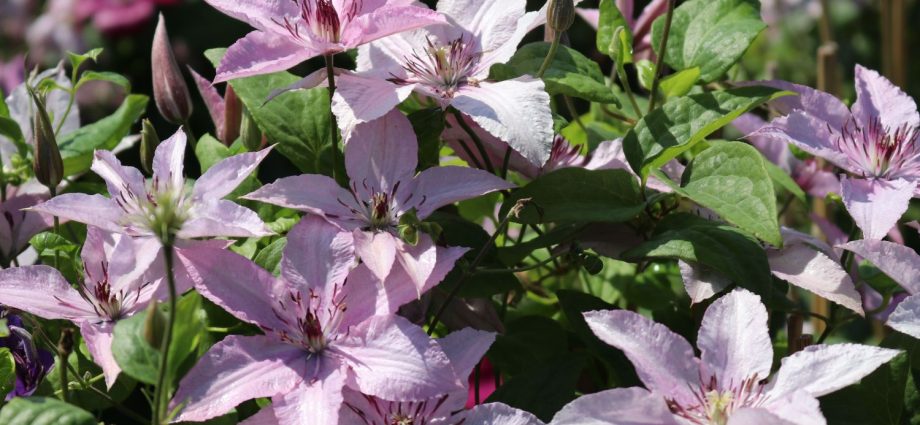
[390,37,482,97]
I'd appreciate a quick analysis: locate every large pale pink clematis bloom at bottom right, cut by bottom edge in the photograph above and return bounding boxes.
[552,289,899,425]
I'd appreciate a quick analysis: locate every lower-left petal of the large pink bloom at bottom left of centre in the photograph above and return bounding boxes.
[170,335,307,422]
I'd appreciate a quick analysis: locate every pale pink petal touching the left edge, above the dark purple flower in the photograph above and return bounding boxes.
[0,266,98,320]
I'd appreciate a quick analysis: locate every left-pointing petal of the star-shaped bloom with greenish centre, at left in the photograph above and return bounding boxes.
[31,193,124,232]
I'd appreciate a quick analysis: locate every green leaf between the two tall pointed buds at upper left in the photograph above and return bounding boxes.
[58,94,149,176]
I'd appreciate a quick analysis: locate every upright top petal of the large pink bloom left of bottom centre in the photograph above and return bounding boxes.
[281,216,355,294]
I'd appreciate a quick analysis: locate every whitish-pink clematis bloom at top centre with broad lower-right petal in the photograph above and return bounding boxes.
[324,0,553,164]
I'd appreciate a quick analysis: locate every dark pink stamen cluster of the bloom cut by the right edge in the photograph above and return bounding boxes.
[836,118,920,179]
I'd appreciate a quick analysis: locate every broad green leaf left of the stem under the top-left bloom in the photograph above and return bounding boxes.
[205,49,332,175]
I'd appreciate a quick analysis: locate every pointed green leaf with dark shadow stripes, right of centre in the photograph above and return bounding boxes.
[623,87,792,179]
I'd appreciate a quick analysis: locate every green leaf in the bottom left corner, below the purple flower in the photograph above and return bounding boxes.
[0,397,96,425]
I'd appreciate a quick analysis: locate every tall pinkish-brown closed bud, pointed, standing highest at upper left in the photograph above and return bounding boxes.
[150,14,192,124]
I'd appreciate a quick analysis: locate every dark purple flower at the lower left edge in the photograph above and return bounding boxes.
[0,307,54,401]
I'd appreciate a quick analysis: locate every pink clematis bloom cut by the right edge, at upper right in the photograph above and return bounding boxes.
[753,65,920,239]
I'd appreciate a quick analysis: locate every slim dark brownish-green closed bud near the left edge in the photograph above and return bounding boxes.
[26,85,64,189]
